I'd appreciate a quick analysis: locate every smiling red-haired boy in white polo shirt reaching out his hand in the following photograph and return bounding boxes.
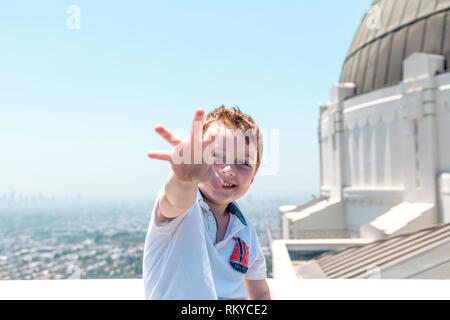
[143,106,271,299]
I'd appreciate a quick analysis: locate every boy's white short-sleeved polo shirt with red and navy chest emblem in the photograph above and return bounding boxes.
[143,187,266,300]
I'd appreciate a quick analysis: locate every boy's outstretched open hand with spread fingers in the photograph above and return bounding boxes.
[148,109,222,189]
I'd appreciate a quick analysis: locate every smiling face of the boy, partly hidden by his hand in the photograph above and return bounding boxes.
[199,123,257,204]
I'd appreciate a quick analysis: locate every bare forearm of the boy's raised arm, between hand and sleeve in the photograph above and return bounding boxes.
[160,171,198,218]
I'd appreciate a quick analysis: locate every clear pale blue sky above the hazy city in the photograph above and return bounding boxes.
[0,0,372,197]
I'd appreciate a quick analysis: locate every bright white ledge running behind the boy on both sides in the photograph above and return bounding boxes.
[0,279,450,300]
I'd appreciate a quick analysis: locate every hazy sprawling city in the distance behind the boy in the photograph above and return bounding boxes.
[0,184,294,280]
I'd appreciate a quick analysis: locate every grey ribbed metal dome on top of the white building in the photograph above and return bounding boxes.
[340,0,450,95]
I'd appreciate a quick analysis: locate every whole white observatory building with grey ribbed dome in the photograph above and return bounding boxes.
[272,0,450,278]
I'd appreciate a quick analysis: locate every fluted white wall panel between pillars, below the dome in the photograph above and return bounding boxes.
[344,92,403,190]
